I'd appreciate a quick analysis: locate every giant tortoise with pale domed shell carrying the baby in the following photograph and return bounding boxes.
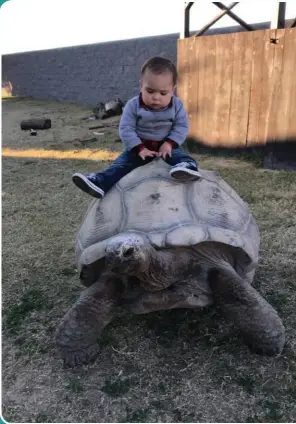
[56,159,285,366]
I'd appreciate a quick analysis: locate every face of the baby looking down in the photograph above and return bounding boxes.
[141,70,175,109]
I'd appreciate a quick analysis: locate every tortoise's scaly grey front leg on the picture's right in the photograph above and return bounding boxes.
[209,267,285,356]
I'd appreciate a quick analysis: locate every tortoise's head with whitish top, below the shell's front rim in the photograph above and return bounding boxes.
[105,235,152,275]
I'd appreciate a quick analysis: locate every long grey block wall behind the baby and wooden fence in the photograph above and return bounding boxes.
[2,22,276,106]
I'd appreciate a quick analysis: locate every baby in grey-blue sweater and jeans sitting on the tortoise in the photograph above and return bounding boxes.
[72,56,200,198]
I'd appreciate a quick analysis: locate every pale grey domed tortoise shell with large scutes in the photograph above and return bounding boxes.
[76,159,259,267]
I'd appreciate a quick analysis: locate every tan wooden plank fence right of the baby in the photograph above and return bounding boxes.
[178,28,296,148]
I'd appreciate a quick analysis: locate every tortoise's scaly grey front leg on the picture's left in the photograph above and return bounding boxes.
[55,274,123,367]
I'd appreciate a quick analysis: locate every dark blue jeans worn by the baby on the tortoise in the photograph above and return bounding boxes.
[95,148,197,193]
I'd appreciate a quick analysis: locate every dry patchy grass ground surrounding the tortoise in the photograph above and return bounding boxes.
[2,98,296,422]
